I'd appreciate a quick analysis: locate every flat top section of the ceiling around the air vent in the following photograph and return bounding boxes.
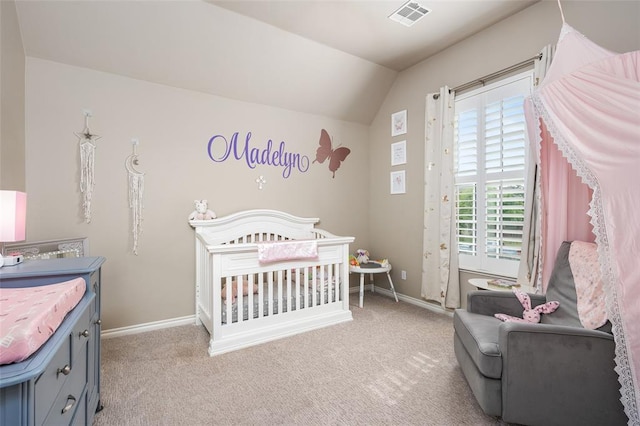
[212,0,539,71]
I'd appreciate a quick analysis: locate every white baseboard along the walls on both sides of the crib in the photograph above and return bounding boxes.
[100,284,453,339]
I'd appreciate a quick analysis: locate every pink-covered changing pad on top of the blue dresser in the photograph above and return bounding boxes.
[0,278,87,364]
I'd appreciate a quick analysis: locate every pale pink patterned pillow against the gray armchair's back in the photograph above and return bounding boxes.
[569,241,607,330]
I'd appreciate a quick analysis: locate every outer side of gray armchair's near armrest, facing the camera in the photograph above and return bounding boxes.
[498,322,624,424]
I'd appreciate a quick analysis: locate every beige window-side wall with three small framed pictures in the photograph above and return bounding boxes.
[369,1,640,298]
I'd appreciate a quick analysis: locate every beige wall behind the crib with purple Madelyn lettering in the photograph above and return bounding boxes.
[26,58,369,330]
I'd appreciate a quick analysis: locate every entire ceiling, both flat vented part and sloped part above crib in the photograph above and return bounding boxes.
[16,0,538,124]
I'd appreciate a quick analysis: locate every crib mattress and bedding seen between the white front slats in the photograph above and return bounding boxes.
[222,284,336,324]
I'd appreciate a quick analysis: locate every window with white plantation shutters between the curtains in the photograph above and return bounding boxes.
[454,71,533,277]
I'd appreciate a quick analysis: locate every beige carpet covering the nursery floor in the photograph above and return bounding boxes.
[94,292,497,426]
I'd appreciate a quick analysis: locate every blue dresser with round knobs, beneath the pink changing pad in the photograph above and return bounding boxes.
[0,257,105,426]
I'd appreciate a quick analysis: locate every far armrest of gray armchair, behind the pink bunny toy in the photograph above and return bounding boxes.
[467,290,547,316]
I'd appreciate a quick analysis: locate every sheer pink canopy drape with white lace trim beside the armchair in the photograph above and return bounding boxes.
[528,23,640,424]
